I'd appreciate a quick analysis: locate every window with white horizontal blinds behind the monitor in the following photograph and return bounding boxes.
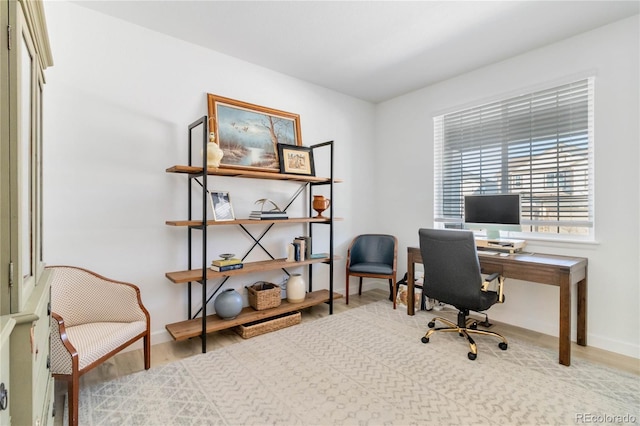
[434,78,594,237]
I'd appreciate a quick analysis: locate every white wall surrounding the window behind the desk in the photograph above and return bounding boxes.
[376,16,640,358]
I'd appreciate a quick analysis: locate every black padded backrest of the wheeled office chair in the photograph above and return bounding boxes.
[418,229,487,310]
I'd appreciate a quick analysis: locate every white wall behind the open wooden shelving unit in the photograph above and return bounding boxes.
[44,2,374,343]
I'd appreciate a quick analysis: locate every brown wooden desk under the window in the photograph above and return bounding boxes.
[407,247,587,366]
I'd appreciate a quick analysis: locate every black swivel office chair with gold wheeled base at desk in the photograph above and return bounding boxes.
[418,229,507,360]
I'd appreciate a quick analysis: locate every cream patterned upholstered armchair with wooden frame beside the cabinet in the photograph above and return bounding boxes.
[48,266,151,426]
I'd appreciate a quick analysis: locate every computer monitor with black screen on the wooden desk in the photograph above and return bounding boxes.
[464,194,522,239]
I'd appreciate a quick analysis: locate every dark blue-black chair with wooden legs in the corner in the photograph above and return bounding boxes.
[346,234,398,309]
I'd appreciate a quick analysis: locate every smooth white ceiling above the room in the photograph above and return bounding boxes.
[75,0,640,102]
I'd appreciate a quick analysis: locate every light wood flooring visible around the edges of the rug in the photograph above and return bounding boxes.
[54,289,640,426]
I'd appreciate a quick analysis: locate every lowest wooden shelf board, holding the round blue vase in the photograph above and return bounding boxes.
[165,290,342,340]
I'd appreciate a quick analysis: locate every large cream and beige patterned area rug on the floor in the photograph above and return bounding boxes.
[65,301,640,425]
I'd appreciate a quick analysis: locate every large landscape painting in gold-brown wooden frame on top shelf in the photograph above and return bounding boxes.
[207,93,302,172]
